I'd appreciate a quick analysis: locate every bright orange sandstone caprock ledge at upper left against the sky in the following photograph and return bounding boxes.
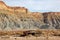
[0,1,27,13]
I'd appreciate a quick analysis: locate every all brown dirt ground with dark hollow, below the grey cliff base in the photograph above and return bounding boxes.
[0,30,60,40]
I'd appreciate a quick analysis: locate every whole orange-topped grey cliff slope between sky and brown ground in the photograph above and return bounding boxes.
[0,2,60,30]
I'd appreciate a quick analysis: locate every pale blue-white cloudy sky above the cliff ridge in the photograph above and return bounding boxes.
[3,0,60,12]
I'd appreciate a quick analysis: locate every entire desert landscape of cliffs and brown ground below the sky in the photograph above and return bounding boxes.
[0,1,60,40]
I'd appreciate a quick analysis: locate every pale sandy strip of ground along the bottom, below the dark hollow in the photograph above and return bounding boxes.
[0,36,60,40]
